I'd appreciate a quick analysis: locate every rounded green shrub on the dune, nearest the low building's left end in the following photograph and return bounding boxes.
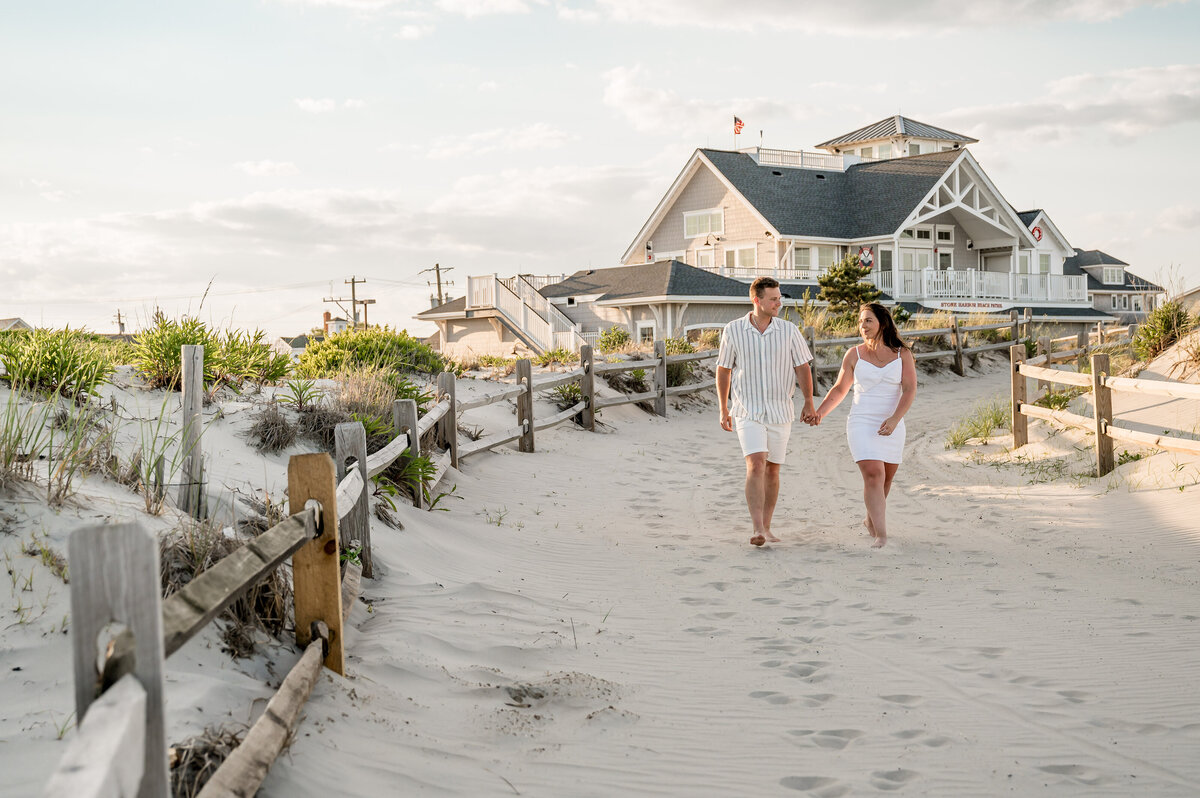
[295,326,448,378]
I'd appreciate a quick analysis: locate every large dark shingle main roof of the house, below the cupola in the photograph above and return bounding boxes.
[701,150,960,239]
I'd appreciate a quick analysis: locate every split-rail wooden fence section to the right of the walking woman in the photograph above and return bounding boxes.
[1010,343,1200,476]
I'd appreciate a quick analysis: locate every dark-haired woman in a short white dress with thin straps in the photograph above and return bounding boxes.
[814,302,917,548]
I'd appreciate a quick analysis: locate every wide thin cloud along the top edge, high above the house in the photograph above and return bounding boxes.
[558,0,1182,37]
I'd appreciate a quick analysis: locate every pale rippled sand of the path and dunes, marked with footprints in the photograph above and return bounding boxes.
[0,352,1200,797]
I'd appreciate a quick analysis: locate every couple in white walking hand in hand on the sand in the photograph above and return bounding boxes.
[716,277,917,548]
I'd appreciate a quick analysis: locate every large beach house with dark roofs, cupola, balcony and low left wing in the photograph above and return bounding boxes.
[418,115,1163,353]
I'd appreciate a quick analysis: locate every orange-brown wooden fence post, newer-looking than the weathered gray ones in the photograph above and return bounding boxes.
[288,452,346,676]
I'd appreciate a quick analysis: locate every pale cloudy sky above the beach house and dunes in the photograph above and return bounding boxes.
[0,0,1200,335]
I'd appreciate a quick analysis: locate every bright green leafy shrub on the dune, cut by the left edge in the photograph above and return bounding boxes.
[0,328,115,398]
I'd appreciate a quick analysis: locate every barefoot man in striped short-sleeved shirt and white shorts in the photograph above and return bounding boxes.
[716,277,816,546]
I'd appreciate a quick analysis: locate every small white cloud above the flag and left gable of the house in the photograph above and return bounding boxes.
[604,66,812,135]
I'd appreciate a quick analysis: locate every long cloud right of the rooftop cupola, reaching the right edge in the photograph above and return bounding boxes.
[938,64,1200,145]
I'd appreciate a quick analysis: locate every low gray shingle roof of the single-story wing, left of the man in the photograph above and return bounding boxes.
[541,260,750,301]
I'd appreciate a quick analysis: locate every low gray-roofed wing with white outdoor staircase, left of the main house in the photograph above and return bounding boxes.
[416,260,750,358]
